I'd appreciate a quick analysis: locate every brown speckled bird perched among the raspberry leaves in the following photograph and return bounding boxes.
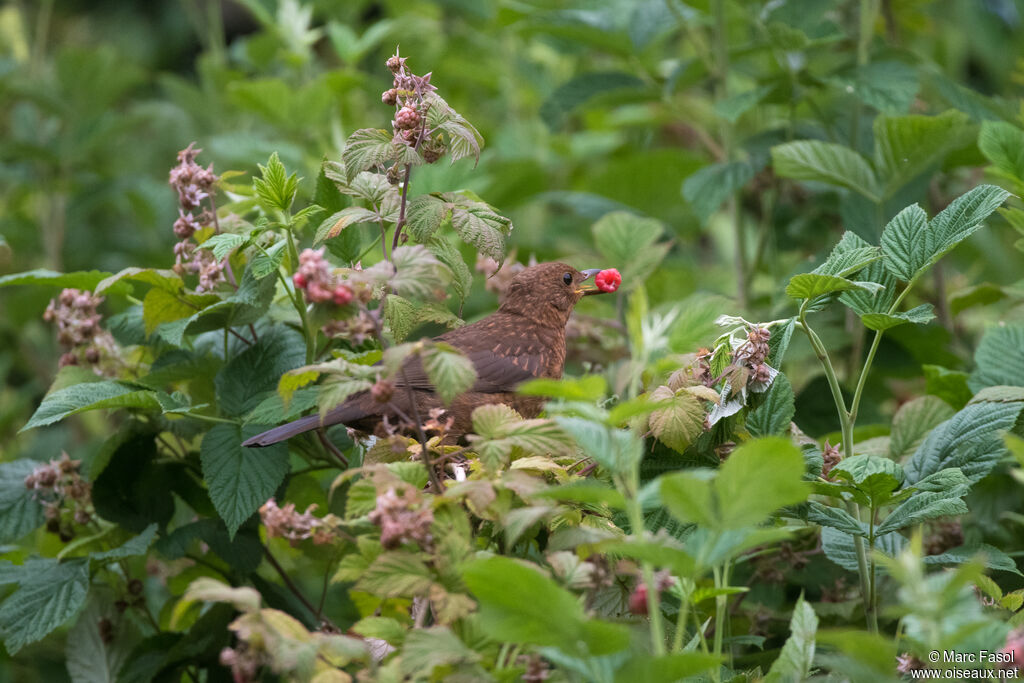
[243,263,602,447]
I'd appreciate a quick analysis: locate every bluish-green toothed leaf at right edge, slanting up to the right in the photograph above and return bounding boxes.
[906,402,1024,483]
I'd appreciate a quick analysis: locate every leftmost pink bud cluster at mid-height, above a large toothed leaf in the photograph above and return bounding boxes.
[43,289,117,368]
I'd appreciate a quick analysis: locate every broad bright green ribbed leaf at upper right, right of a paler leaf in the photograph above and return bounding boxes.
[872,111,976,198]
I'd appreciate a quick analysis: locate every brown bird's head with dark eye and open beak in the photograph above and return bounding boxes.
[501,262,604,327]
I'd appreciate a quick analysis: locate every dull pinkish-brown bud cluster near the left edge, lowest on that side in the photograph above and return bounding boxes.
[25,453,93,543]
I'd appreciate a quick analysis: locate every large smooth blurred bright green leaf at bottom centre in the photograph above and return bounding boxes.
[462,556,630,655]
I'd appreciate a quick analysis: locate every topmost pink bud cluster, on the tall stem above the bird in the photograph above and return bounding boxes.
[381,51,446,164]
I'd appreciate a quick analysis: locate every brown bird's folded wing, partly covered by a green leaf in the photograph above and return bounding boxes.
[395,343,546,393]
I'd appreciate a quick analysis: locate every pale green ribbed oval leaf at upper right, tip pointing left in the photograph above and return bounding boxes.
[771,140,879,201]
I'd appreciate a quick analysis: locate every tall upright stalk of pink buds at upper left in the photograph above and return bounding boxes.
[169,142,224,293]
